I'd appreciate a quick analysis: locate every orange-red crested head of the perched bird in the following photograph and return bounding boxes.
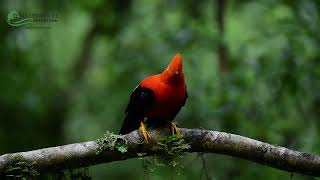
[161,53,184,85]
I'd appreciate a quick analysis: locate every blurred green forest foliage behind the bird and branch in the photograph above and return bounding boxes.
[0,0,320,180]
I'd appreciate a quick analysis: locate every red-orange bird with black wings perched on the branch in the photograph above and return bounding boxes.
[120,54,188,142]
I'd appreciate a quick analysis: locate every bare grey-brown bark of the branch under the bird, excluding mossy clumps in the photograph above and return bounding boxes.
[0,128,320,177]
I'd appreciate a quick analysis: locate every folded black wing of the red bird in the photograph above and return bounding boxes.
[119,86,155,134]
